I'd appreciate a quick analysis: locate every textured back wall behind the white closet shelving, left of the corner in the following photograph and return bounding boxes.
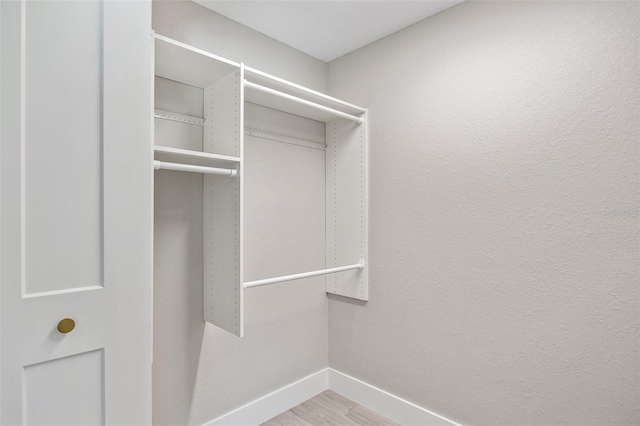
[153,2,328,425]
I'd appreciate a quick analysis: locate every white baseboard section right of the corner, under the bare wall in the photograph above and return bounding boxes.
[328,368,461,426]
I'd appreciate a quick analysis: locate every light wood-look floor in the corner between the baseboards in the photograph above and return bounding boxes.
[262,391,398,426]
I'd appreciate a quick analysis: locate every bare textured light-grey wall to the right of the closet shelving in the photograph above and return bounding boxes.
[329,2,640,425]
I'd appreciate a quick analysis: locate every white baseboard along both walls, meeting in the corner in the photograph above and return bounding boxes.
[204,368,460,426]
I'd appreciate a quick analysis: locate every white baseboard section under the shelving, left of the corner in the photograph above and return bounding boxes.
[205,368,329,426]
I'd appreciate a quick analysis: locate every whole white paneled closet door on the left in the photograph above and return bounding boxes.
[0,1,152,425]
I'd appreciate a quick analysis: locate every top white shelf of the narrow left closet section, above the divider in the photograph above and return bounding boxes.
[154,34,240,88]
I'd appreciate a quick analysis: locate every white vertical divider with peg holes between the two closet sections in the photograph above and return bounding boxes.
[203,66,244,337]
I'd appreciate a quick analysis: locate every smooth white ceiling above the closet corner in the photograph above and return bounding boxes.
[194,0,464,62]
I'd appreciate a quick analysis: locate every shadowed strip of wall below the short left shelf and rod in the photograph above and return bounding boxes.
[153,171,205,424]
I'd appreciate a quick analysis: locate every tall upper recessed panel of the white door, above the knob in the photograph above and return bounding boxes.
[23,1,103,294]
